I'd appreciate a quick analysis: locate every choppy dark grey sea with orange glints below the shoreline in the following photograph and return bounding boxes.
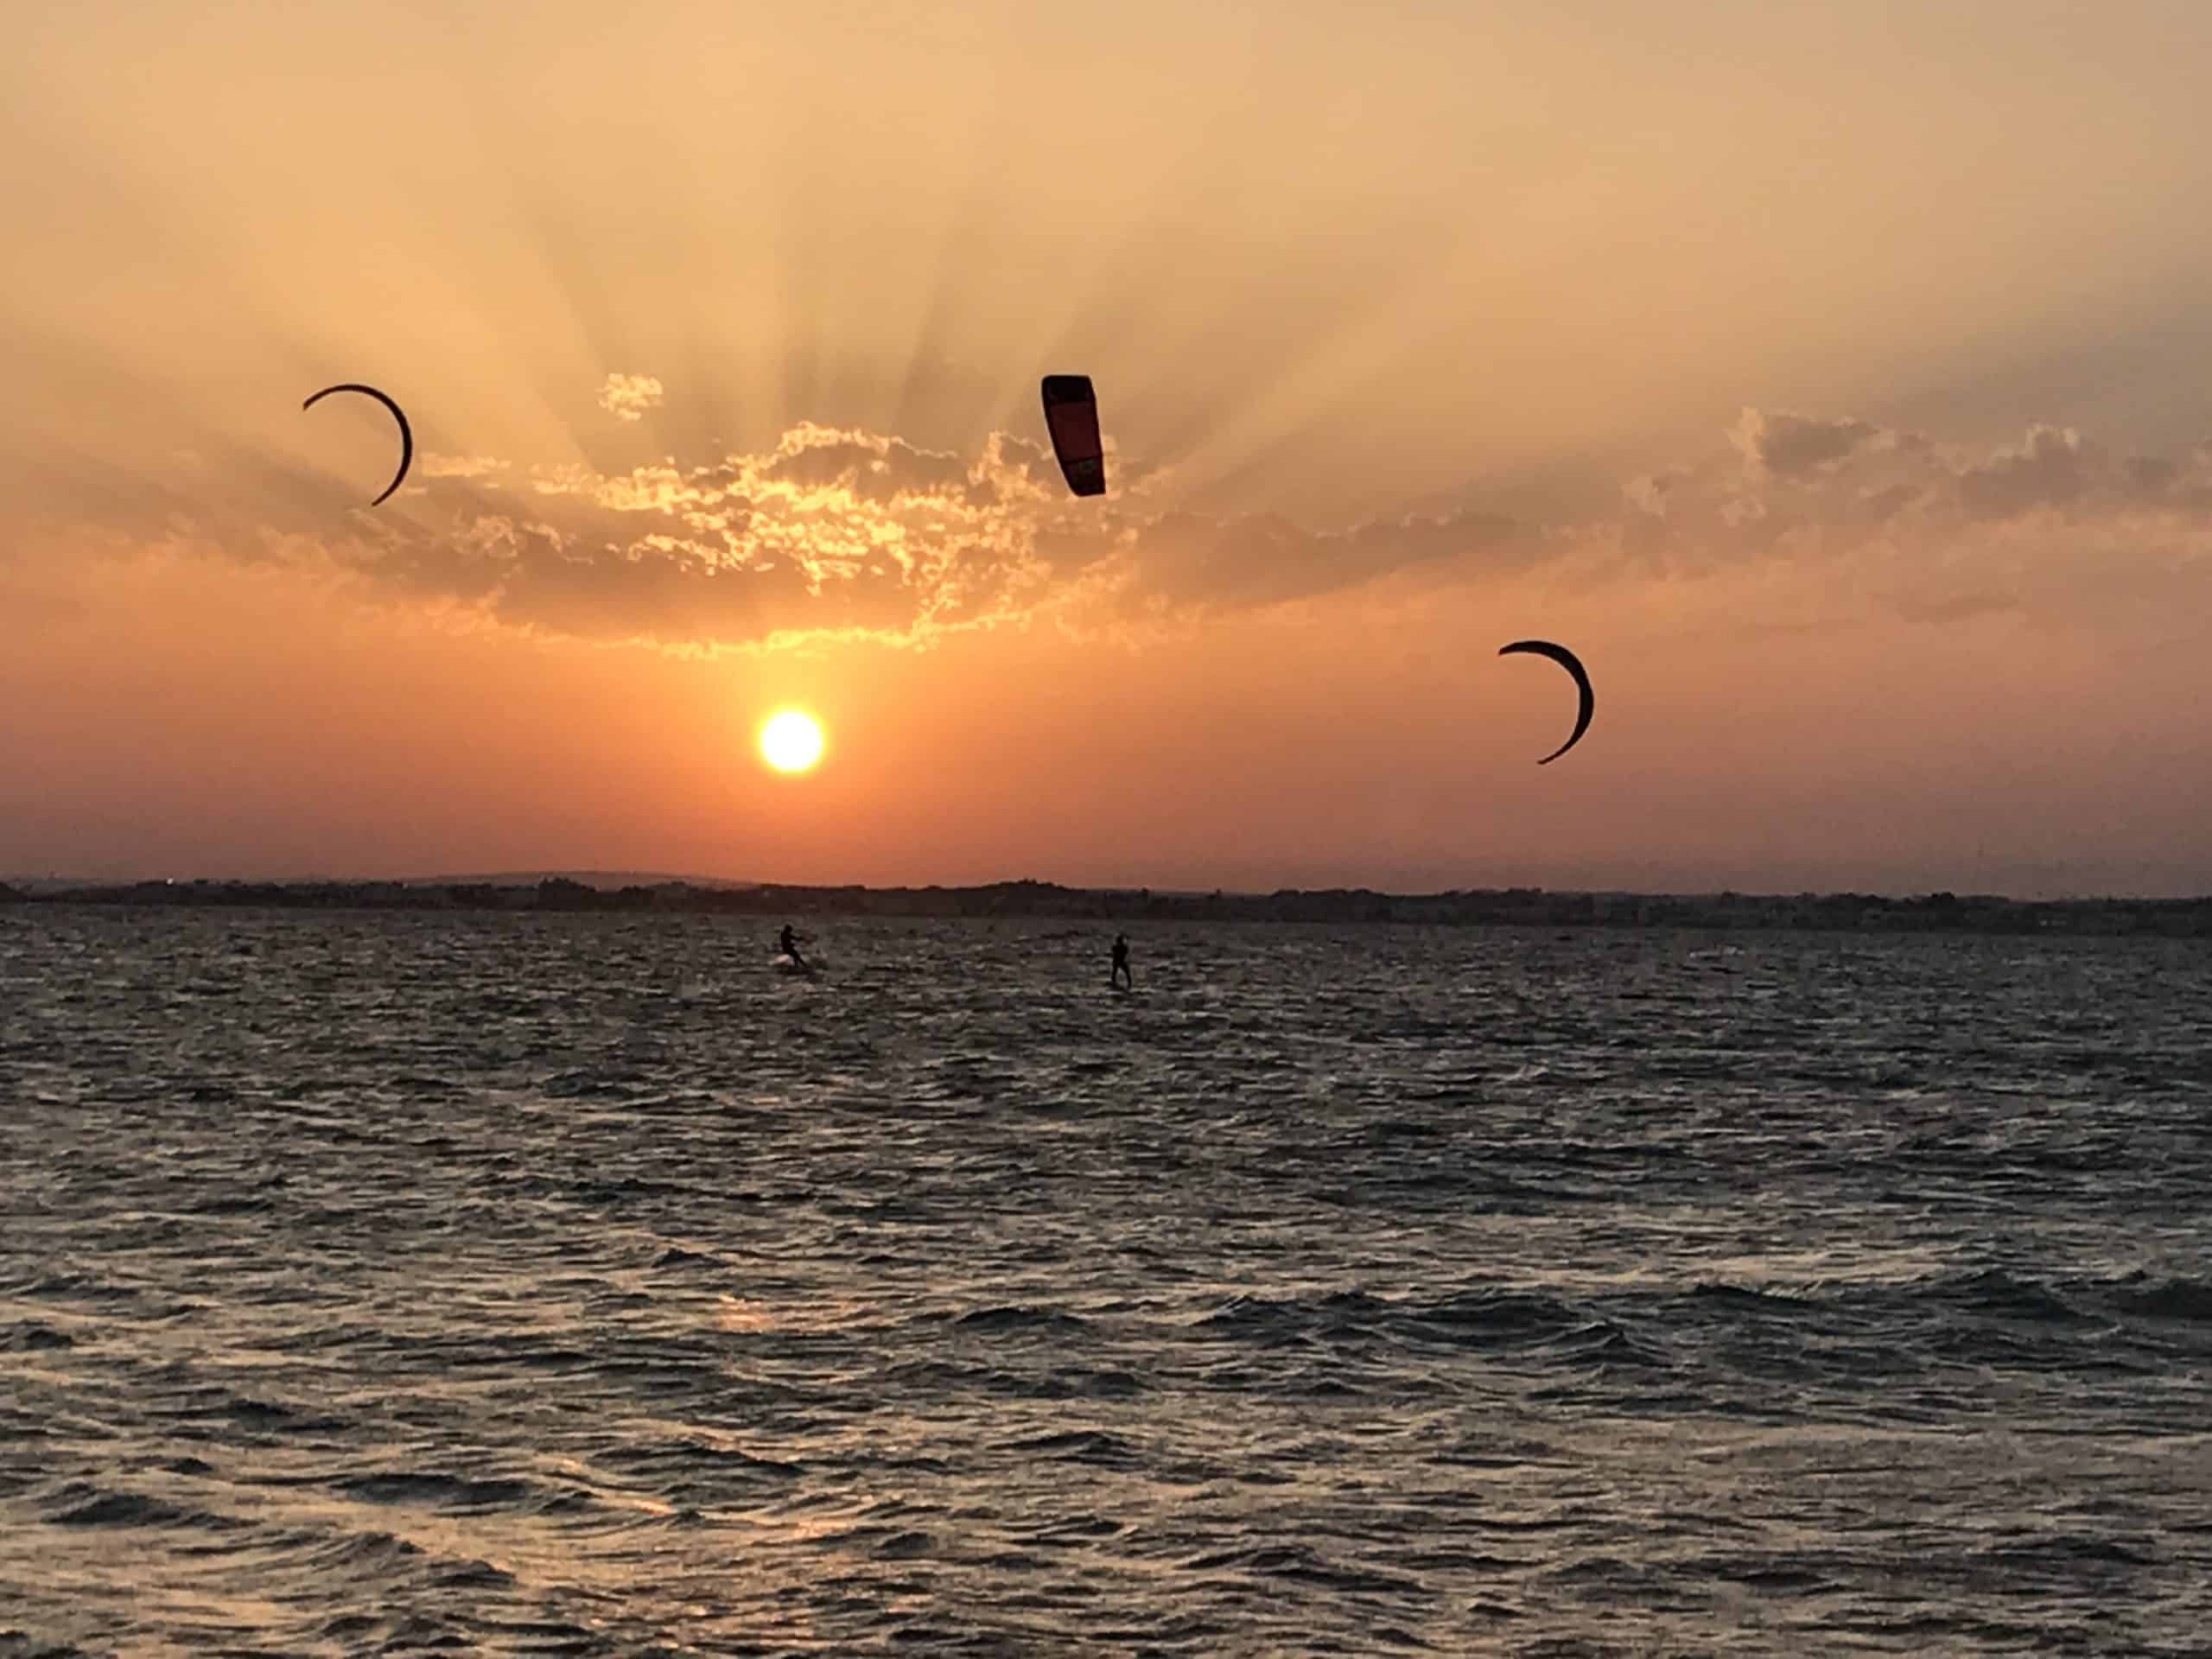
[0,909,2212,1659]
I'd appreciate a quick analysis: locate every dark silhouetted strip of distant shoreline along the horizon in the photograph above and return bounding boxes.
[0,876,2212,938]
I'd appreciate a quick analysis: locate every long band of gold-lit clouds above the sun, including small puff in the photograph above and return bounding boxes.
[30,407,2212,651]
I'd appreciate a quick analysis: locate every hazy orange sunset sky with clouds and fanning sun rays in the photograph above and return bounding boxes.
[0,0,2212,893]
